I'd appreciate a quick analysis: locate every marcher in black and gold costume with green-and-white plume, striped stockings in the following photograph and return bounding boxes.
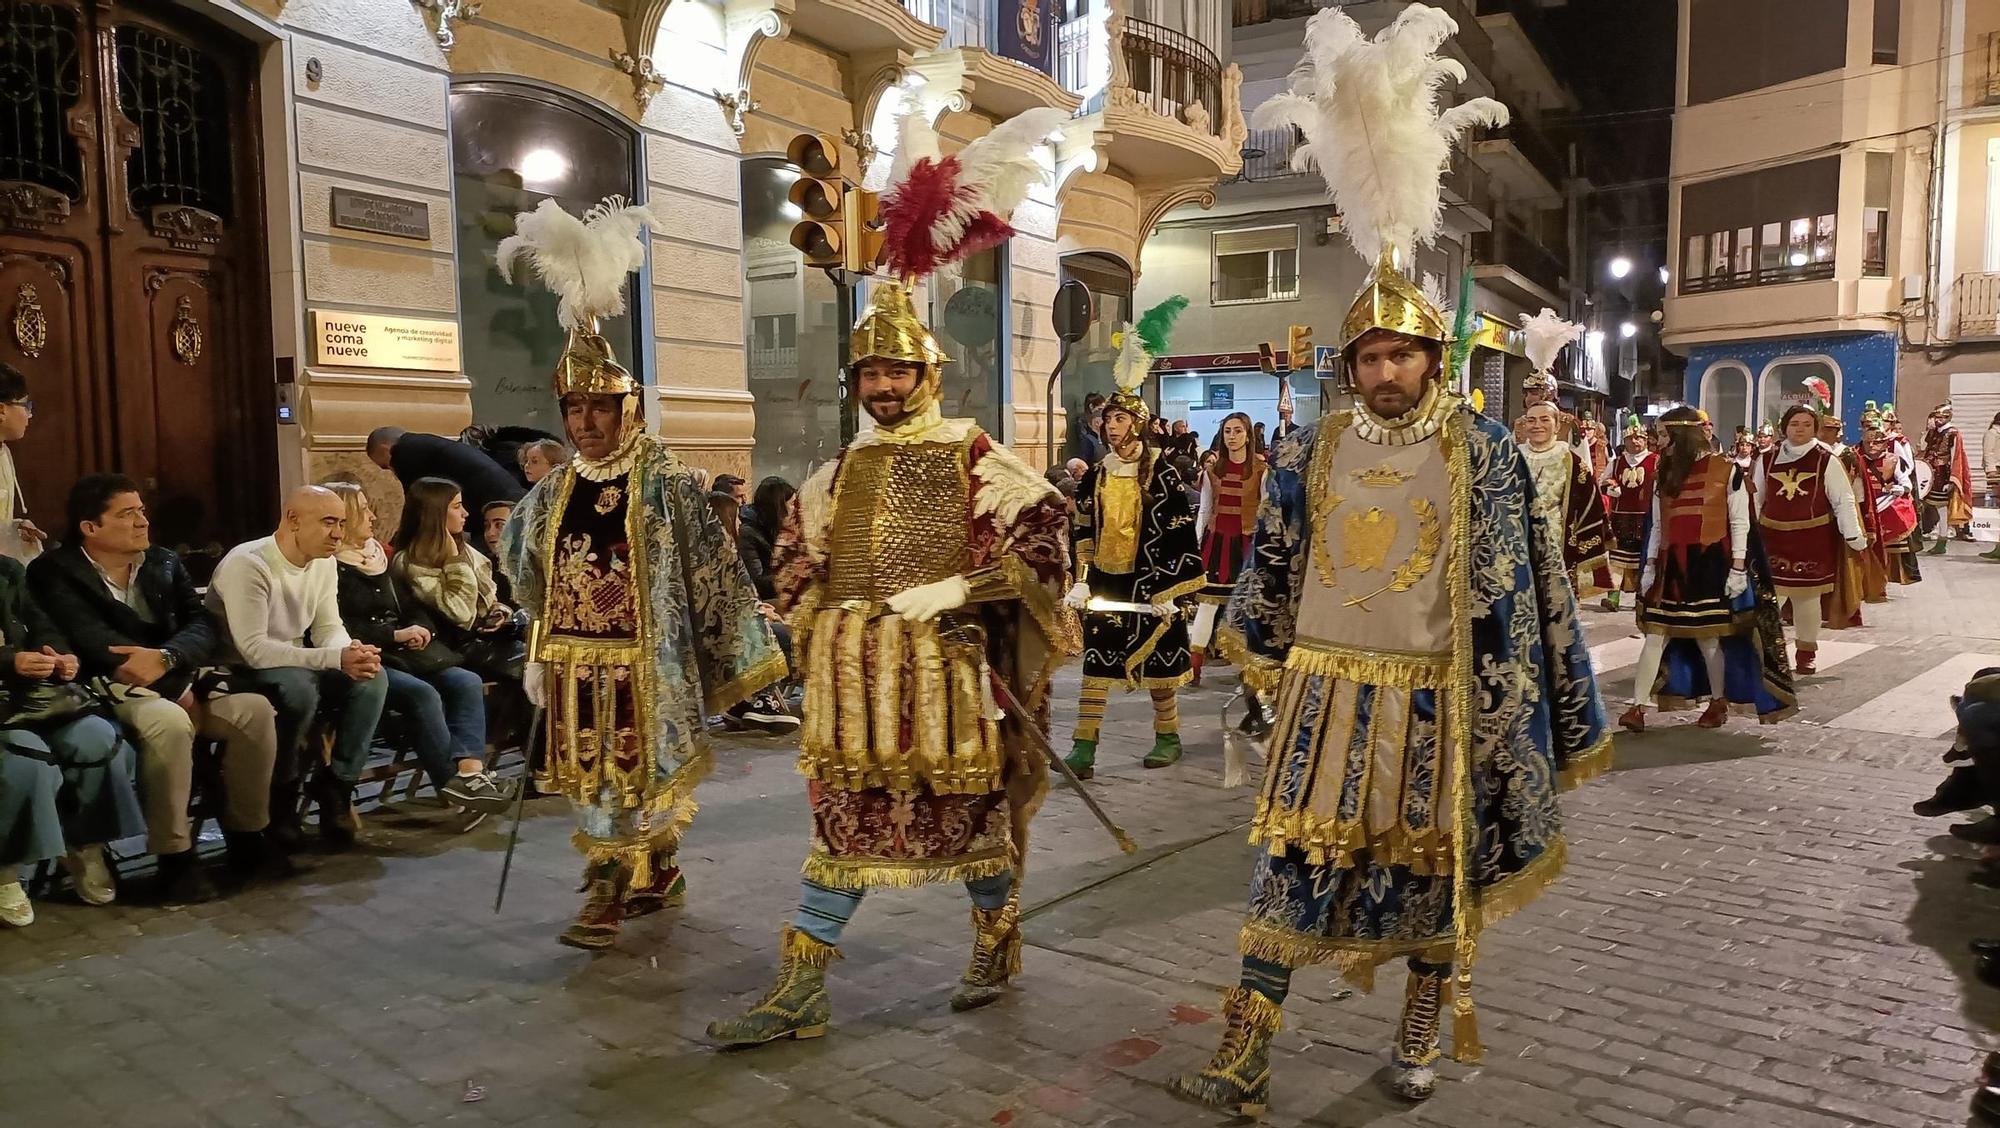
[1064,296,1200,780]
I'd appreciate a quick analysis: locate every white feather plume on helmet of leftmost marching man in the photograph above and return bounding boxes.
[494,196,658,328]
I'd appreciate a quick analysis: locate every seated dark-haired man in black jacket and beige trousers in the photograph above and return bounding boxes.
[28,474,294,904]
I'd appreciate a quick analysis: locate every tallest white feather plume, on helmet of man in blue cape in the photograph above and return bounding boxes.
[1252,4,1508,262]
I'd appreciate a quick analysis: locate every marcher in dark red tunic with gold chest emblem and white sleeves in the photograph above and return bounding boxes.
[1752,396,1868,674]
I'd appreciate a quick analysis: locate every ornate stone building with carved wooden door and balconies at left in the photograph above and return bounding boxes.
[0,0,1242,564]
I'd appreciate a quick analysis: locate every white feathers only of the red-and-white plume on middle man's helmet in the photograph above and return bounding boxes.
[884,90,1070,266]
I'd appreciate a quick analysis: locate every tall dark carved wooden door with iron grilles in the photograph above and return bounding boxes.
[0,0,276,574]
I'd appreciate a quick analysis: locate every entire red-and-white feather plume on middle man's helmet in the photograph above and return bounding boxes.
[880,96,1070,280]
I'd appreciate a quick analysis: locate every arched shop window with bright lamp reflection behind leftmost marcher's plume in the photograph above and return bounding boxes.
[452,82,646,434]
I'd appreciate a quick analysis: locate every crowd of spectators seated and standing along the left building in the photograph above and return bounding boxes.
[0,364,798,926]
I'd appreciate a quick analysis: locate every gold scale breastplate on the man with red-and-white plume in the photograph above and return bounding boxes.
[826,442,972,602]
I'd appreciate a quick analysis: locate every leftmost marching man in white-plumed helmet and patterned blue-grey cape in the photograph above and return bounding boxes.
[498,198,784,948]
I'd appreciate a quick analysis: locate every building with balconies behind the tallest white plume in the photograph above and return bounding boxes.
[1136,0,1606,448]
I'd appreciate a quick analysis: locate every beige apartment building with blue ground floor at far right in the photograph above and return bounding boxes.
[1664,0,2000,450]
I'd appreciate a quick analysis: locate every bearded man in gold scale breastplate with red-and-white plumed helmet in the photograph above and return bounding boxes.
[708,98,1080,1046]
